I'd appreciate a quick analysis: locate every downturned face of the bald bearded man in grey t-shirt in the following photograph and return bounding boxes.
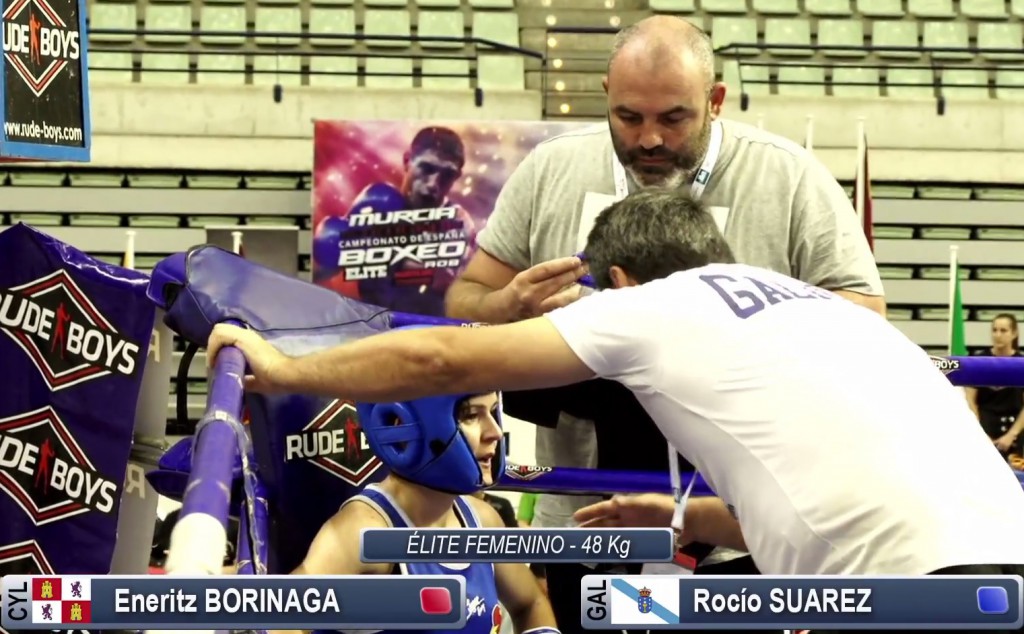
[605,54,725,188]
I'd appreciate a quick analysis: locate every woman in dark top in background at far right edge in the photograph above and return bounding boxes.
[966,312,1024,456]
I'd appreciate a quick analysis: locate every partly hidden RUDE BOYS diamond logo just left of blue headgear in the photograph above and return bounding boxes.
[285,399,381,487]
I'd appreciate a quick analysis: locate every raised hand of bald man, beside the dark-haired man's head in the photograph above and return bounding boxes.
[499,257,587,320]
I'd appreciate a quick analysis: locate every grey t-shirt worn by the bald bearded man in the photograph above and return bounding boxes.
[477,120,883,526]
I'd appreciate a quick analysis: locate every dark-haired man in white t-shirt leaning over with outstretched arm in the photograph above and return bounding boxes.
[210,191,1024,585]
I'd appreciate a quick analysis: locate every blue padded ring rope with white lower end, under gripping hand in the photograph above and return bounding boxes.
[165,319,247,576]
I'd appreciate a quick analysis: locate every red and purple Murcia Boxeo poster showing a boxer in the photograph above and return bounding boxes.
[312,121,592,316]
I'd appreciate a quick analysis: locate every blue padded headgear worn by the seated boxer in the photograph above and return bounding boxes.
[355,327,505,495]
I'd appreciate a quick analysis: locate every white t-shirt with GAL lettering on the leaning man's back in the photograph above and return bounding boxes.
[547,264,1024,575]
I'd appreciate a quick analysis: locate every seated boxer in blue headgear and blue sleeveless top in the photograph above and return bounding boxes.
[294,378,558,634]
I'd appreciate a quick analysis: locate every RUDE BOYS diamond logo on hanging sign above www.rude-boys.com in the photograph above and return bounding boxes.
[3,0,82,97]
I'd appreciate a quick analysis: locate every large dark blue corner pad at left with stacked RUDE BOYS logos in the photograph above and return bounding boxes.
[0,224,155,577]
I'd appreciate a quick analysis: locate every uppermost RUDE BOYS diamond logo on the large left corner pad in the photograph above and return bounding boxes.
[0,268,140,391]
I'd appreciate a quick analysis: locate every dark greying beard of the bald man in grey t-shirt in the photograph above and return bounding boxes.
[608,112,712,189]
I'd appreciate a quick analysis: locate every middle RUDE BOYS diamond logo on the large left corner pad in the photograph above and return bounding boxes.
[0,406,120,526]
